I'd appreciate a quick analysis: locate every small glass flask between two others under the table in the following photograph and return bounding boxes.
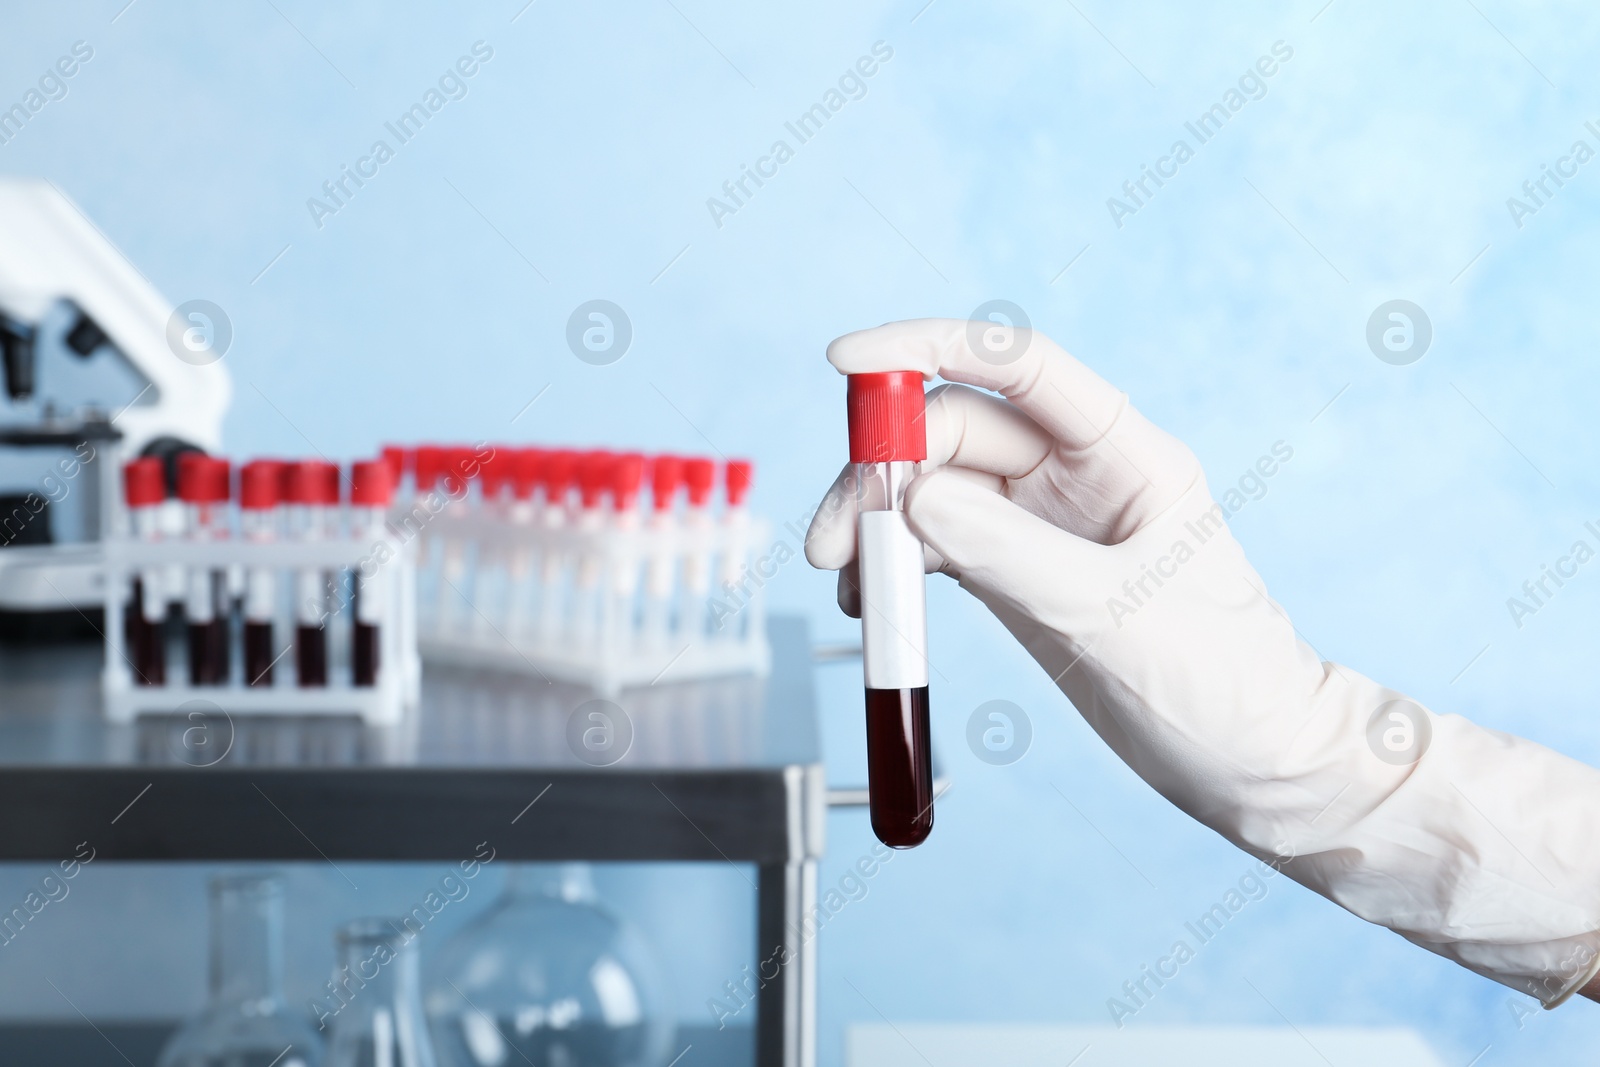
[323,918,437,1067]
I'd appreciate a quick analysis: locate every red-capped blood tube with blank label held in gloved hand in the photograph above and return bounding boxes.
[846,371,933,848]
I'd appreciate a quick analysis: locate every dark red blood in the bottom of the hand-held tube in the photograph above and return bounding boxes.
[867,686,933,848]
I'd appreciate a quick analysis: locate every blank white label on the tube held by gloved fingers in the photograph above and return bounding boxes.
[861,512,928,689]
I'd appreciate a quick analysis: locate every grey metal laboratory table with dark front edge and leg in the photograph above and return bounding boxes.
[0,616,827,1067]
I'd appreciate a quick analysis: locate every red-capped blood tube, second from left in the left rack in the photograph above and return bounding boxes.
[178,453,232,685]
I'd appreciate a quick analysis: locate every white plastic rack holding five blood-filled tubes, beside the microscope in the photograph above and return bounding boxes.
[102,461,421,725]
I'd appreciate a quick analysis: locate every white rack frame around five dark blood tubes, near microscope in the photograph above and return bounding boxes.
[102,451,421,725]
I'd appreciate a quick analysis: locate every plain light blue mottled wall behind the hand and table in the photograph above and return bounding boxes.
[0,0,1600,1064]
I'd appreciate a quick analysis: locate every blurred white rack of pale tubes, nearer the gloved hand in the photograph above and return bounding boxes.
[398,448,771,696]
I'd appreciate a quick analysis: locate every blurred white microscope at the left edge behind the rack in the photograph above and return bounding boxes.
[0,176,232,638]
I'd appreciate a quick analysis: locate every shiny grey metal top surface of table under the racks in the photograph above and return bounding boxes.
[0,616,821,771]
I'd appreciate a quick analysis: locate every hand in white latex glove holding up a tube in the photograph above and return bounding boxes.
[806,320,1600,1006]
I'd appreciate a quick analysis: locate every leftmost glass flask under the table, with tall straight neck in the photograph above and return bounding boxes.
[157,875,322,1067]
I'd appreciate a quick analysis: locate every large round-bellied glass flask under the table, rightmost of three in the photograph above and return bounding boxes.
[427,864,674,1067]
